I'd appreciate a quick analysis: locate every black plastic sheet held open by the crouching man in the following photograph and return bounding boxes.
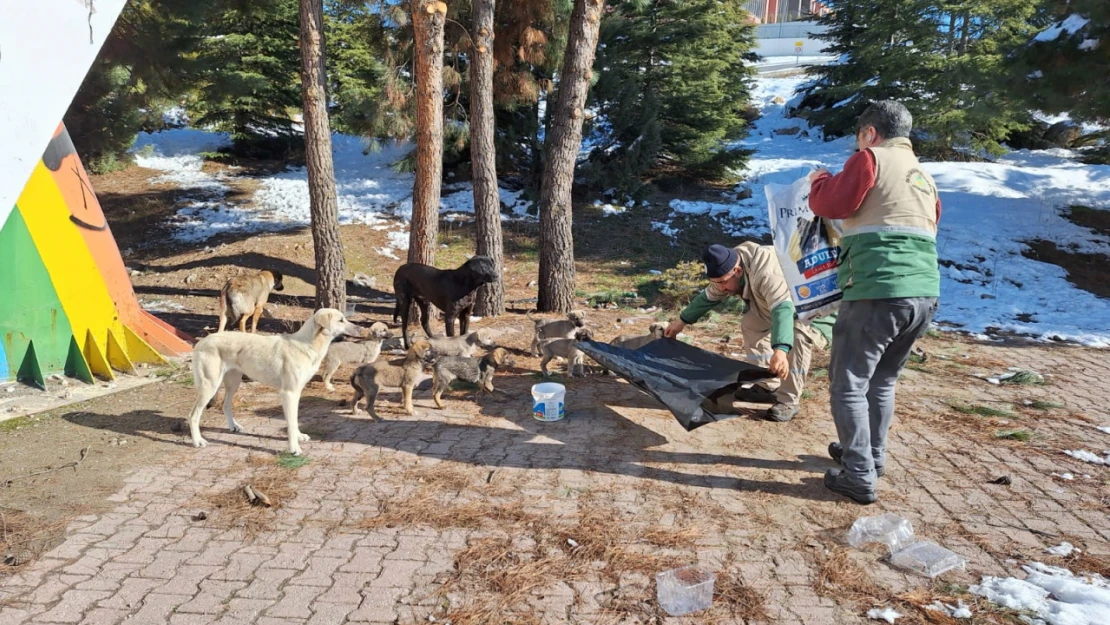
[578,339,773,432]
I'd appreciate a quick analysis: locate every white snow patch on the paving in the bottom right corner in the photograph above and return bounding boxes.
[969,562,1110,625]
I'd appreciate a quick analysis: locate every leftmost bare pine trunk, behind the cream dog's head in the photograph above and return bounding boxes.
[300,0,346,312]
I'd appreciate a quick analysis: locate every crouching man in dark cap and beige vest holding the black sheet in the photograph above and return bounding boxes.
[665,242,835,422]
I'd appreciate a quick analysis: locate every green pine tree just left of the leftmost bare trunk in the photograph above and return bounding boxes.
[191,0,301,158]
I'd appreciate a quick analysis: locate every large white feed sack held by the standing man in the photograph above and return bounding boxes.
[764,175,844,321]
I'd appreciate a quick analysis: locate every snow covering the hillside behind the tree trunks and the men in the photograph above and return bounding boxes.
[129,78,1110,346]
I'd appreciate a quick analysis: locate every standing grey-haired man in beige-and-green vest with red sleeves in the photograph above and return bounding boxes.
[809,100,940,504]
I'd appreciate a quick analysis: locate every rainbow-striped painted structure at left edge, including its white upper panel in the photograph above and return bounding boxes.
[0,0,190,387]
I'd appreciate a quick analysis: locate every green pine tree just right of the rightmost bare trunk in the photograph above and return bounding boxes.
[591,0,755,188]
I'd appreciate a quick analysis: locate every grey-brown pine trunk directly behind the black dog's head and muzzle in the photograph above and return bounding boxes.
[471,0,505,316]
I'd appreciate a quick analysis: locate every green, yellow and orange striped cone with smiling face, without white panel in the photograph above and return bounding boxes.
[0,125,190,386]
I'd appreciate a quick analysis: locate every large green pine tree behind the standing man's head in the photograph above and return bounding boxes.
[801,0,1037,155]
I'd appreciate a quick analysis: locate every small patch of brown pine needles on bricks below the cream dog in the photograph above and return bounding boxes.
[197,454,296,537]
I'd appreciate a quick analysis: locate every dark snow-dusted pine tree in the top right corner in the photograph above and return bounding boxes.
[1011,0,1110,124]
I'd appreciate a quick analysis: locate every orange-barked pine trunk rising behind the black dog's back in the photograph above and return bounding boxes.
[408,0,447,264]
